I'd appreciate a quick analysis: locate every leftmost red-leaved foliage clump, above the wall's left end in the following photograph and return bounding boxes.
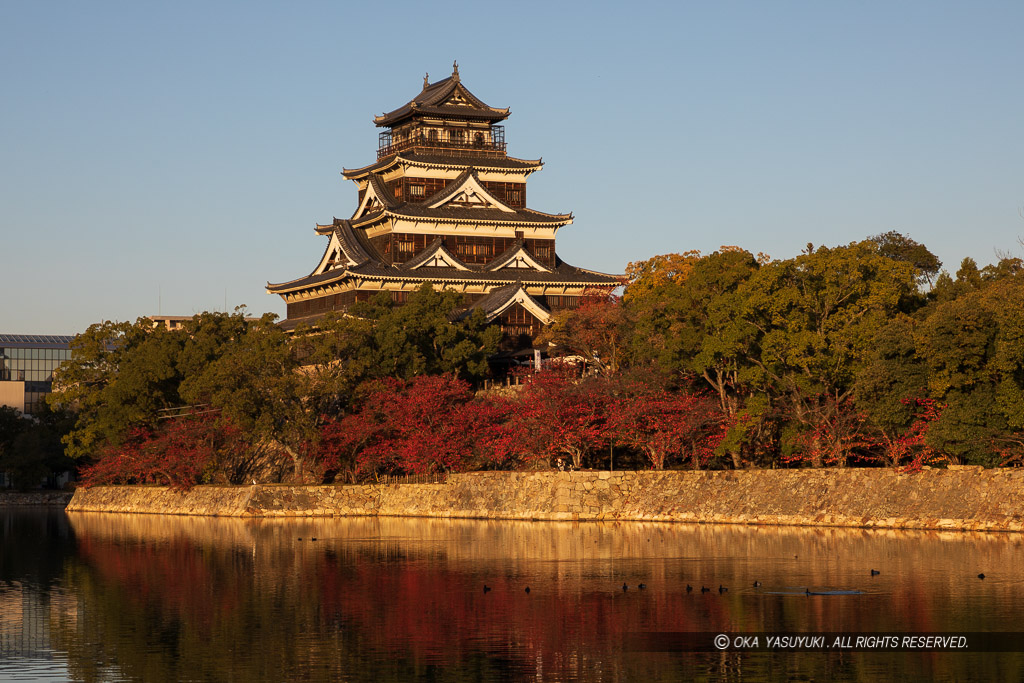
[81,417,248,489]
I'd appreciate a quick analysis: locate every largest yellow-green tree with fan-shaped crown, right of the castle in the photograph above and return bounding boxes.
[741,241,918,465]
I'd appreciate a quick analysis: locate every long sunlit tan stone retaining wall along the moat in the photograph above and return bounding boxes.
[68,467,1024,531]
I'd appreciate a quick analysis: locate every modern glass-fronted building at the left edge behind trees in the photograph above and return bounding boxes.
[0,334,74,415]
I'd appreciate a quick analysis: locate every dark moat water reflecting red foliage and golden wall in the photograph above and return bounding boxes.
[0,508,1024,683]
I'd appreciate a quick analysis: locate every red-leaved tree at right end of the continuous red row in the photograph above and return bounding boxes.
[608,391,726,470]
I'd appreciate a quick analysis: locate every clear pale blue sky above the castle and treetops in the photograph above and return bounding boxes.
[0,0,1024,334]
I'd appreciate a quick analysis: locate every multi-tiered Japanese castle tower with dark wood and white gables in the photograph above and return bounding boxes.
[266,63,620,345]
